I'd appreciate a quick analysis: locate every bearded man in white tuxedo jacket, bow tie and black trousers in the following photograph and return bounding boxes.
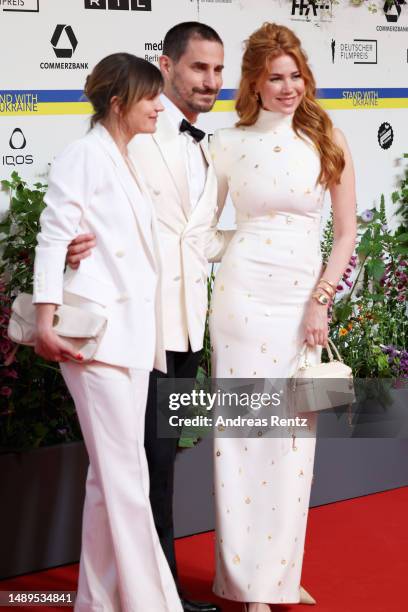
[68,22,233,612]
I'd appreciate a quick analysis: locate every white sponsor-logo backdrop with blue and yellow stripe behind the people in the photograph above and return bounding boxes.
[0,0,408,225]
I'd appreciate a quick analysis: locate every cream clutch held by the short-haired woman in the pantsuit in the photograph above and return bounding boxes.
[8,293,107,363]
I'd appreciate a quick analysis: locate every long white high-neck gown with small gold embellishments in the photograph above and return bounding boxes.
[210,110,324,603]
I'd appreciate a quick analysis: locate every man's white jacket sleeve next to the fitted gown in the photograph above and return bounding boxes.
[205,130,235,263]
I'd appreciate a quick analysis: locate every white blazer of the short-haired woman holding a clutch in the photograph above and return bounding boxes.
[33,124,166,371]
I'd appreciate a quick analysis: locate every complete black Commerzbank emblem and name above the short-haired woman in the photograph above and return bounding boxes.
[40,23,89,70]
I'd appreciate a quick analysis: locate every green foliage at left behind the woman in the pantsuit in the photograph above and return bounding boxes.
[0,172,81,451]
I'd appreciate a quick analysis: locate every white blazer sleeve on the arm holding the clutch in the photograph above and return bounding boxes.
[33,140,100,304]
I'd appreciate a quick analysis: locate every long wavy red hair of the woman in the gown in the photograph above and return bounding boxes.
[236,22,344,187]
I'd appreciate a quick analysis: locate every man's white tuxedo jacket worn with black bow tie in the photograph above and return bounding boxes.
[129,111,234,351]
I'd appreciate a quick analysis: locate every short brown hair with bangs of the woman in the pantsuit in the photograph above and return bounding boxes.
[84,53,163,127]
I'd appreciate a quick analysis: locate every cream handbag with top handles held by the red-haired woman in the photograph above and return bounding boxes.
[291,339,355,413]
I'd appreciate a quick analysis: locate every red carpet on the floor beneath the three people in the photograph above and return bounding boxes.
[0,487,408,612]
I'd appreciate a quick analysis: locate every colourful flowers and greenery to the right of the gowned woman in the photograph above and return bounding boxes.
[322,155,408,378]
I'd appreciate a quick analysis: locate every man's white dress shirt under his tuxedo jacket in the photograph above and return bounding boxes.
[161,94,207,210]
